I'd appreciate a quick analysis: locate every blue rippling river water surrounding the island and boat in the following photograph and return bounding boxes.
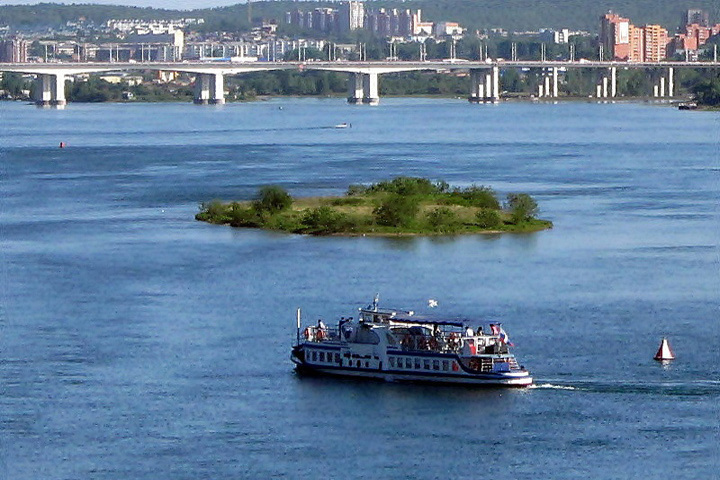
[0,99,720,480]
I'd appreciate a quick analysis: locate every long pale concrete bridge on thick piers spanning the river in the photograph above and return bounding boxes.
[0,59,720,105]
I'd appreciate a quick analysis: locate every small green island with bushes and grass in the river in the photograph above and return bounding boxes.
[195,177,552,236]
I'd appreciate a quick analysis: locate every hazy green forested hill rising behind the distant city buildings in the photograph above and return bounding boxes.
[0,0,720,33]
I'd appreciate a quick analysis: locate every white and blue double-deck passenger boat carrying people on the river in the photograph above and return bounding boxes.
[290,297,533,387]
